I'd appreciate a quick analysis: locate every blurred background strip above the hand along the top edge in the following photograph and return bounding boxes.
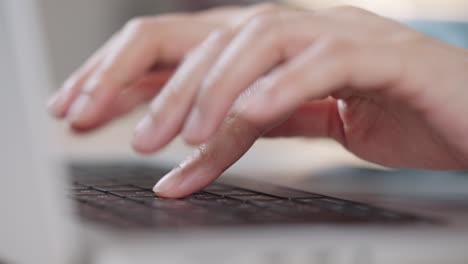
[40,0,468,82]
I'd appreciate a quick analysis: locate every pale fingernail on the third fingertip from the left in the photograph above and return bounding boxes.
[133,116,157,152]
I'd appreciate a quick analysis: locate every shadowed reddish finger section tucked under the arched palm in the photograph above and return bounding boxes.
[263,97,345,143]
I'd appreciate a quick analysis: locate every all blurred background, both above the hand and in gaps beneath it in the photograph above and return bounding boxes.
[40,0,468,192]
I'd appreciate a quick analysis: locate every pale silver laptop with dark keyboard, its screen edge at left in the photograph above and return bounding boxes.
[0,0,468,264]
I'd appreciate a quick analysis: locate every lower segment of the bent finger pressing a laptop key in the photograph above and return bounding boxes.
[153,113,261,198]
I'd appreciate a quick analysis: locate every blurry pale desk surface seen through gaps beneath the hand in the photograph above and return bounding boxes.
[60,107,375,183]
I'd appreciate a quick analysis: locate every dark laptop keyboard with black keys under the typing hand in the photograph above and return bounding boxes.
[69,164,428,229]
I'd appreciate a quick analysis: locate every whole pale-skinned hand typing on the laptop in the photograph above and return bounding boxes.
[48,5,468,198]
